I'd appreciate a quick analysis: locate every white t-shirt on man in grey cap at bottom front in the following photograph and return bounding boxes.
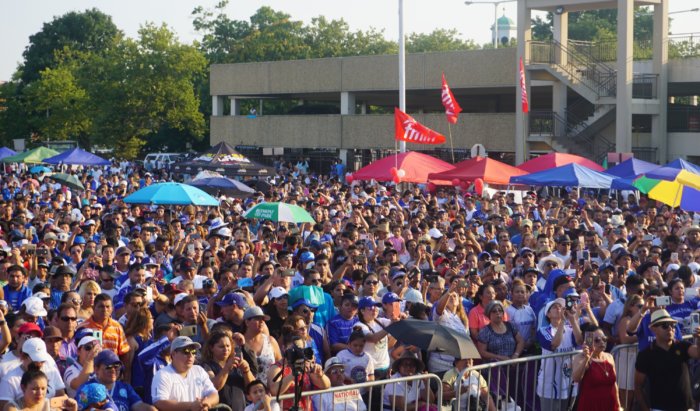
[151,364,217,404]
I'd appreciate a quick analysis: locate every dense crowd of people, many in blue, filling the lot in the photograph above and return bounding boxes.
[0,159,700,411]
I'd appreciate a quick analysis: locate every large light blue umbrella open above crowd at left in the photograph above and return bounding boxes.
[124,183,219,207]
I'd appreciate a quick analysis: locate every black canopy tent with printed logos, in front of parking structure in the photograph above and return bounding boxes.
[173,142,275,176]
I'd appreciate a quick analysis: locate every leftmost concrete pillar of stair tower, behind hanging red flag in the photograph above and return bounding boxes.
[513,0,532,164]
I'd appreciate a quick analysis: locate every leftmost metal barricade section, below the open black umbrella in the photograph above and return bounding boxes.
[279,374,442,411]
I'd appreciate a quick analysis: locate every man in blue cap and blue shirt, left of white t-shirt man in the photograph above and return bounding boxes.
[89,350,156,411]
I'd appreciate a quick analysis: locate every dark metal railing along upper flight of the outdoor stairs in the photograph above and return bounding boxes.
[528,41,617,97]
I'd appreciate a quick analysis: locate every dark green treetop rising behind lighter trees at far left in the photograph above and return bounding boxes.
[21,8,119,84]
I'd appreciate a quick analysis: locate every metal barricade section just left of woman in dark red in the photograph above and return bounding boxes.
[452,350,581,411]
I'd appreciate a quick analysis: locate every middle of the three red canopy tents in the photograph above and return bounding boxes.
[428,157,527,185]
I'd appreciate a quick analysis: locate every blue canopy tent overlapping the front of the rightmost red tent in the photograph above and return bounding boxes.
[510,163,615,189]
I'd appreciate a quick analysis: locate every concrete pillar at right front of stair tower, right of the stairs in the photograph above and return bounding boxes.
[615,0,634,153]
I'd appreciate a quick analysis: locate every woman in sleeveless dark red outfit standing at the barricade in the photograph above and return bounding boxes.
[571,328,620,411]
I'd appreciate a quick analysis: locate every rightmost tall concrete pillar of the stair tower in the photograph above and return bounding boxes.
[651,0,669,164]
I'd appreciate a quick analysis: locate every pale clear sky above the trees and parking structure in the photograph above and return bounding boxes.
[0,0,700,80]
